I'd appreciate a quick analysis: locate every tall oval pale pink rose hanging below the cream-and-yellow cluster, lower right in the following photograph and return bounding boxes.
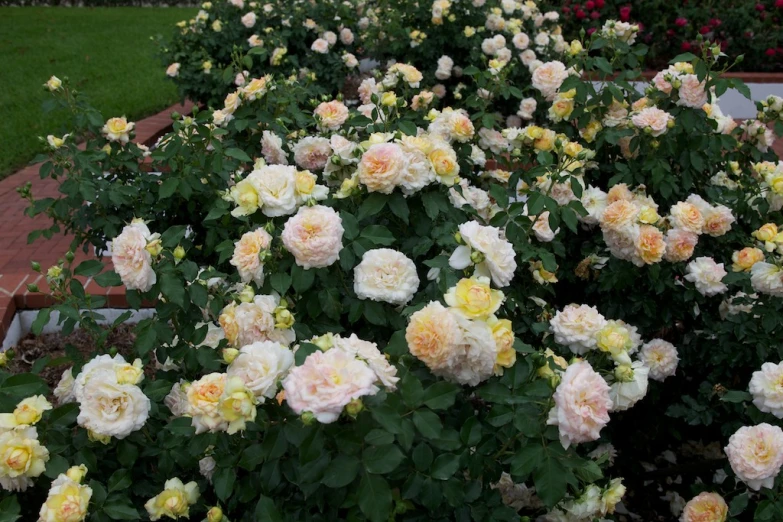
[547,361,612,448]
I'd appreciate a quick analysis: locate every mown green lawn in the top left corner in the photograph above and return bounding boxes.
[0,7,196,178]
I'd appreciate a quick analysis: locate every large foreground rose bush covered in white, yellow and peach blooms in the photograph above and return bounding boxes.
[0,9,783,521]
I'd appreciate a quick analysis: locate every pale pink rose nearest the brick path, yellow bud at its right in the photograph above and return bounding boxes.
[111,223,157,292]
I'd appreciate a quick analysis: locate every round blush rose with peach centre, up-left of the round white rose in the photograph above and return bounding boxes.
[281,205,343,269]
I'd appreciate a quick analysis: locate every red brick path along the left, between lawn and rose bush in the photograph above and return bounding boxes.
[0,102,193,341]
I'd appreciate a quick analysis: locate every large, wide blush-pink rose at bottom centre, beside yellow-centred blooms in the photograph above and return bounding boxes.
[283,350,378,424]
